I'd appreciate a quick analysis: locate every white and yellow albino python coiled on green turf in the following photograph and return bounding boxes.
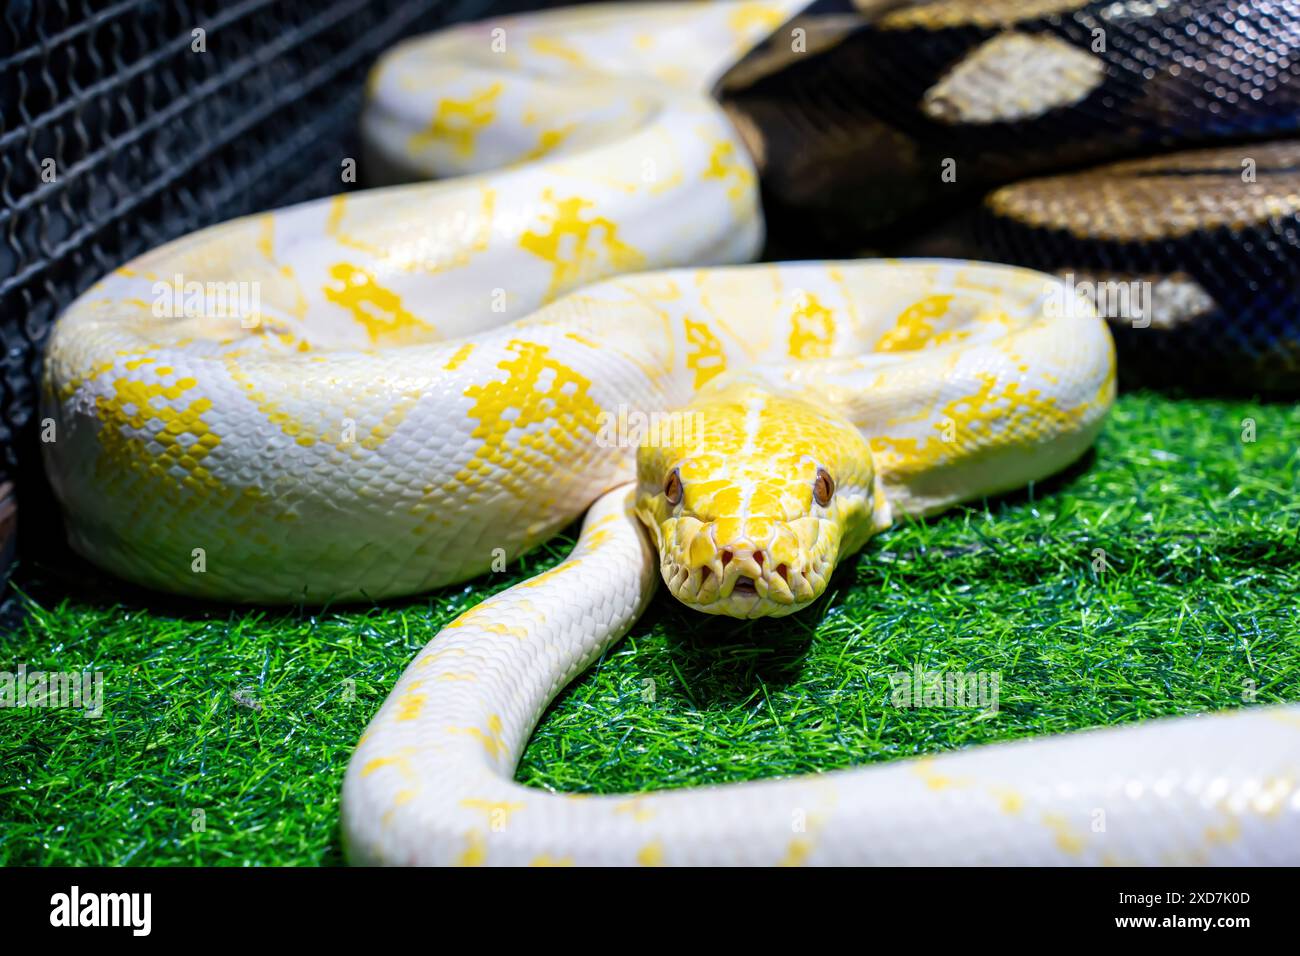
[44,3,1300,864]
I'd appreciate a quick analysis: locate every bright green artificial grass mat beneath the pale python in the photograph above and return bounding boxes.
[0,393,1300,865]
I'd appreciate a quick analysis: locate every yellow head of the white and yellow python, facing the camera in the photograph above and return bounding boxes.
[637,385,874,618]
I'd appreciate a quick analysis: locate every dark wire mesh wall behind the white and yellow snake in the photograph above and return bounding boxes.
[0,0,553,502]
